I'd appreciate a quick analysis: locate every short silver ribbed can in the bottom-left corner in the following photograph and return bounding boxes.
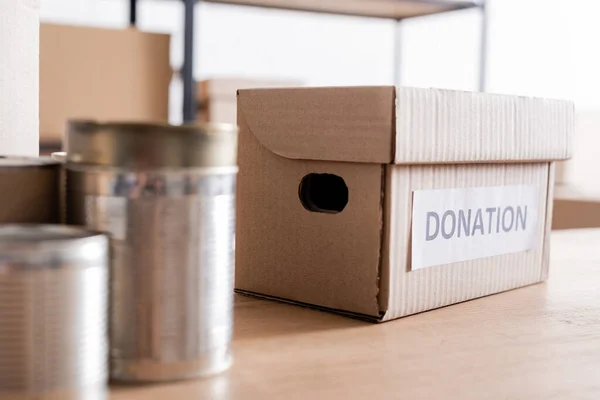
[0,225,109,400]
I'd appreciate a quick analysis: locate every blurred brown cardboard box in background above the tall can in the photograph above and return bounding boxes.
[40,24,172,145]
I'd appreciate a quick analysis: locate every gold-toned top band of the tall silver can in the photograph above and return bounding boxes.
[66,120,237,168]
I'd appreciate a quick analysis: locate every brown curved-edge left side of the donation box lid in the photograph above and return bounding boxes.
[238,86,395,164]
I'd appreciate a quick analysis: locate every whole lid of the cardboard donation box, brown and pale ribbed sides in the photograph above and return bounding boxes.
[238,86,574,164]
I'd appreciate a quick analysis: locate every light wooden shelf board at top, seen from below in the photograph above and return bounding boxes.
[209,0,474,19]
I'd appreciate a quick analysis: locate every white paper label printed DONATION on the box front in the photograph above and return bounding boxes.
[411,185,540,271]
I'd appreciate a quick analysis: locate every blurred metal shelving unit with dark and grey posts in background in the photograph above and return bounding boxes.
[129,0,487,122]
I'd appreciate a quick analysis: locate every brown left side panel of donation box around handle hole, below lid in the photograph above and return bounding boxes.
[236,109,382,316]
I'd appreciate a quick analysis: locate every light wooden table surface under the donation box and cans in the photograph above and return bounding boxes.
[110,230,600,400]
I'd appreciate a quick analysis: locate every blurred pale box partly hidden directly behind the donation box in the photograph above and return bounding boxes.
[196,78,302,124]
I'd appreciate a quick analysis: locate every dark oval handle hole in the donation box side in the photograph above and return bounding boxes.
[298,174,348,214]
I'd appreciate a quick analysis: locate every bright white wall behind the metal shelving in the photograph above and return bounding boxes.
[42,0,600,117]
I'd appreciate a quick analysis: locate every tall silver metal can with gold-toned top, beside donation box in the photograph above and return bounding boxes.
[66,121,237,381]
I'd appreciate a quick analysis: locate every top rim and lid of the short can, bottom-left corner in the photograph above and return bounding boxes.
[0,224,108,272]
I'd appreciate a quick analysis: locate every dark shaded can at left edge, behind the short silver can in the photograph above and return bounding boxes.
[0,157,61,224]
